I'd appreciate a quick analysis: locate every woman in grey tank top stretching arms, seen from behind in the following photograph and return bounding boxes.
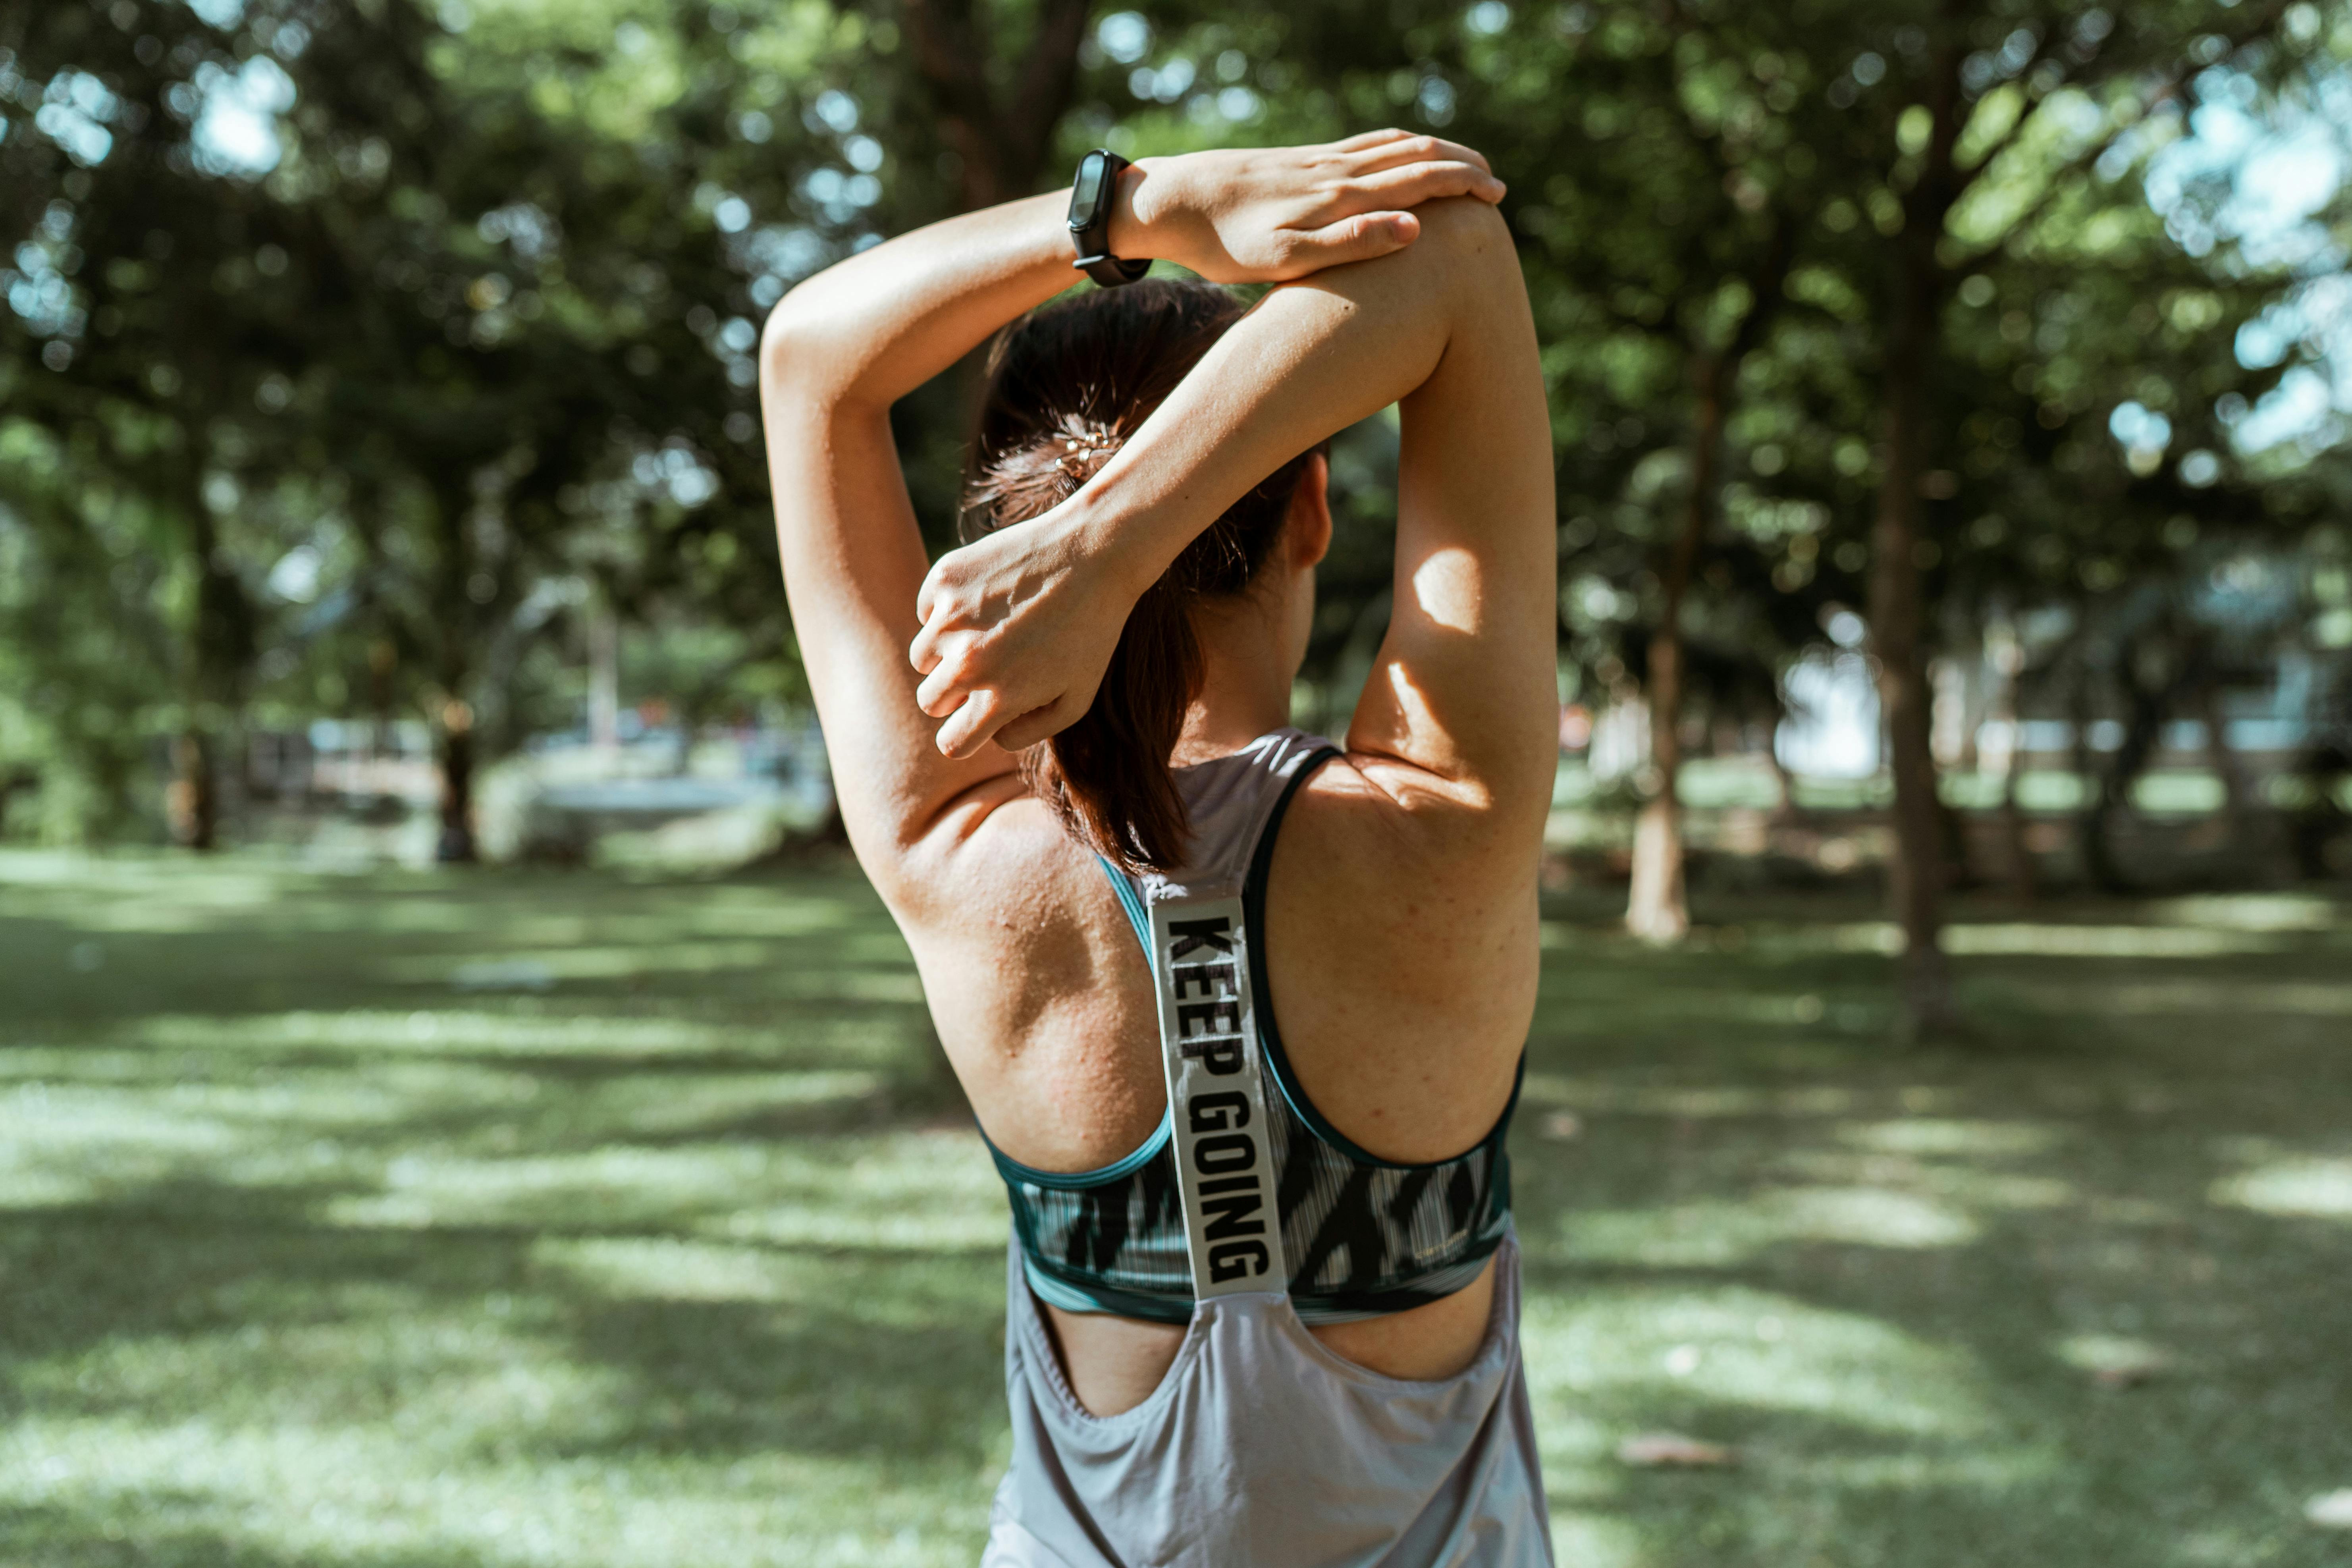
[762,132,1555,1568]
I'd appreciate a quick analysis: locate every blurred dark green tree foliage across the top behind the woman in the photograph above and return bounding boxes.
[0,0,2336,846]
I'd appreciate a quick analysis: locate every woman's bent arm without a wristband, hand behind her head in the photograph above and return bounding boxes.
[913,202,1557,837]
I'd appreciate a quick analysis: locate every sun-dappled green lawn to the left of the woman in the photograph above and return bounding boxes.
[0,856,1004,1568]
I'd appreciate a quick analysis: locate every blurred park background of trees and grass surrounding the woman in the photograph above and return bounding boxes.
[0,0,2352,1568]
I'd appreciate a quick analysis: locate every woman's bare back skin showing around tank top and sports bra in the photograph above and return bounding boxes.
[917,757,1536,1415]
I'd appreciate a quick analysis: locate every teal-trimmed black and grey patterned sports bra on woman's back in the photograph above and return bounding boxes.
[981,729,1527,1323]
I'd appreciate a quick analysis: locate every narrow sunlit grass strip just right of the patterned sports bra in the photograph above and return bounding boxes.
[1560,1187,1978,1267]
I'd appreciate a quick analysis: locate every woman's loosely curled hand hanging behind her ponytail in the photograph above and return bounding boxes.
[908,503,1141,757]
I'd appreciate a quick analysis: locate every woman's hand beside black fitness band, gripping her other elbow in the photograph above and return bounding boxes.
[1110,132,1503,282]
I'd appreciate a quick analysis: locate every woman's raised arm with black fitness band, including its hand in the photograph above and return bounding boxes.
[760,132,1501,881]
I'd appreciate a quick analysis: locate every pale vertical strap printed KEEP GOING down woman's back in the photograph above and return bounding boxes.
[1150,893,1291,1300]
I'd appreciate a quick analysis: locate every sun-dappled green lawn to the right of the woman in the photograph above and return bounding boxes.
[1515,888,2352,1568]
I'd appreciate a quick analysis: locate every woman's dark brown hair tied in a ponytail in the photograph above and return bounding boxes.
[960,278,1313,872]
